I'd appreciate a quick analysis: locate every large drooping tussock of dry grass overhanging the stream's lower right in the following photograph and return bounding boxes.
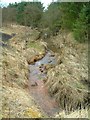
[46,75,89,112]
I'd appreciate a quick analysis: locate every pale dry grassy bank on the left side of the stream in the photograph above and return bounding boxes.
[0,26,45,118]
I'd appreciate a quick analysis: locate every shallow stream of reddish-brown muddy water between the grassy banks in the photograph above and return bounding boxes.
[29,51,59,117]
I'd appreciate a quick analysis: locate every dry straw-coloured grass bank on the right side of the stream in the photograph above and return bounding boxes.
[46,32,90,117]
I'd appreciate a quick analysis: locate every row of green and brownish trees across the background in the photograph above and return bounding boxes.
[2,2,90,42]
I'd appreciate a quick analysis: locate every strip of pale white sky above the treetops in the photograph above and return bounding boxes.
[0,0,56,7]
